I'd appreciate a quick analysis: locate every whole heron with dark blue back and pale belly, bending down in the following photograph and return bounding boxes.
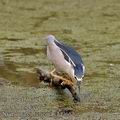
[47,35,85,98]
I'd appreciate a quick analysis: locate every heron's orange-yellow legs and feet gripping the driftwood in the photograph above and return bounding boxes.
[50,69,73,86]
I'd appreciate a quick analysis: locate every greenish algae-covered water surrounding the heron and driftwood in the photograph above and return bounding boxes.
[0,0,120,120]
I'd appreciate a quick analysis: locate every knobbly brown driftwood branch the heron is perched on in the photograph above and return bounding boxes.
[37,69,80,102]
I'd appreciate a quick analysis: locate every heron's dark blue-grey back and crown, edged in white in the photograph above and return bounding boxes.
[55,40,85,78]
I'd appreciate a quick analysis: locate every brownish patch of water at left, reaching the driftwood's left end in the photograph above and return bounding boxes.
[0,58,39,87]
